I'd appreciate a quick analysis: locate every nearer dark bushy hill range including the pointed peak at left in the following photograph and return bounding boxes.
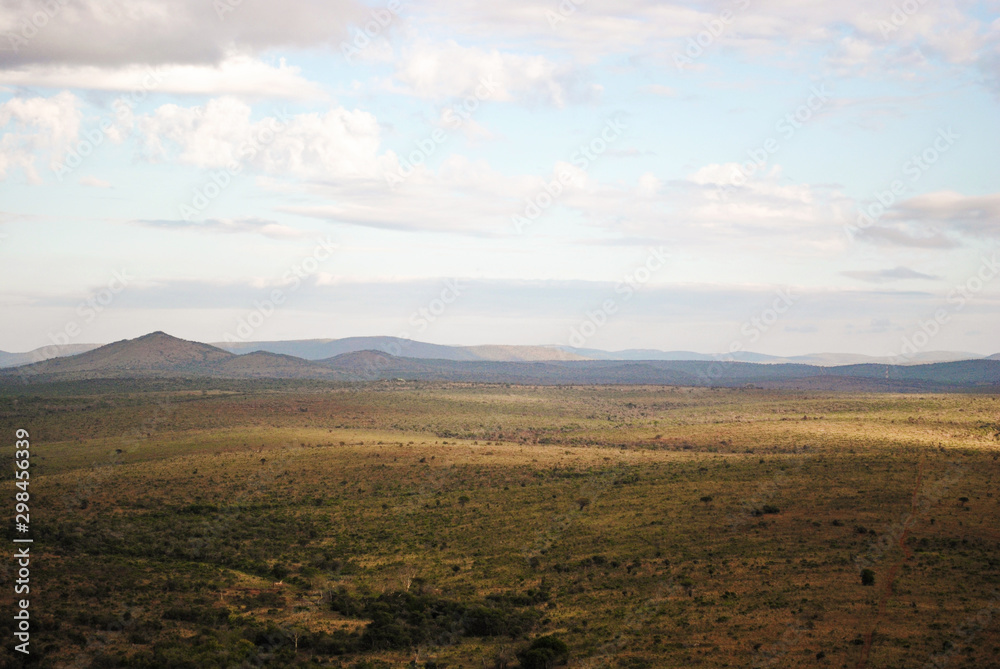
[0,332,1000,392]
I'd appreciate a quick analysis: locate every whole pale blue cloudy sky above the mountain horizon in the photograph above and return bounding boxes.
[0,0,1000,356]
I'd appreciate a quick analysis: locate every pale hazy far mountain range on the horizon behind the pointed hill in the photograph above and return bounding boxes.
[0,337,1000,368]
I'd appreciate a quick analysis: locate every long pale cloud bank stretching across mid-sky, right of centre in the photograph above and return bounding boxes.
[279,155,847,245]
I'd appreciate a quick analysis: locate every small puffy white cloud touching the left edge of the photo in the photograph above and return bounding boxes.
[0,91,83,184]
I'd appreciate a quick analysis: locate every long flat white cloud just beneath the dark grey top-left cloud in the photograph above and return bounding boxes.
[0,54,322,99]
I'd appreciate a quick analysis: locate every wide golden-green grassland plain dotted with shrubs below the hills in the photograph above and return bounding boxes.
[0,381,1000,669]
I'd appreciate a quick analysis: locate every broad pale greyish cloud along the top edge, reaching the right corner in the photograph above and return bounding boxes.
[413,0,998,90]
